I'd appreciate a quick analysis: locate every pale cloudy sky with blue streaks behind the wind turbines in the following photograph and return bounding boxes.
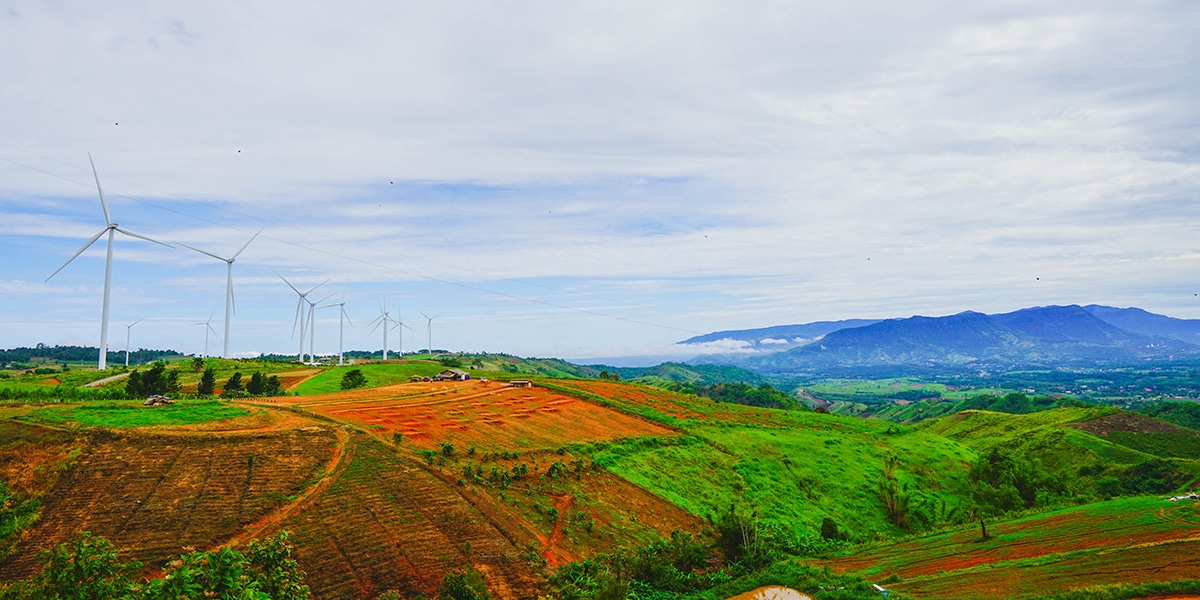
[0,0,1200,358]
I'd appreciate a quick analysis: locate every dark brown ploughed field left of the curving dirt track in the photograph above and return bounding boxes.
[0,426,335,581]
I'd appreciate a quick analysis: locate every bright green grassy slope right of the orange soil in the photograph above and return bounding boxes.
[580,409,974,541]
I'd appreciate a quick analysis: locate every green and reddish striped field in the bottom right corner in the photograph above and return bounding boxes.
[822,497,1200,599]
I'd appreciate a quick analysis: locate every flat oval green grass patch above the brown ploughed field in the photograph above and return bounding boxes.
[11,400,251,428]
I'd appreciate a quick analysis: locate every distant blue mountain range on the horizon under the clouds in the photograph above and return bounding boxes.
[679,305,1200,373]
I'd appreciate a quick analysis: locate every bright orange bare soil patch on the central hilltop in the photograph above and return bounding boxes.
[288,382,676,450]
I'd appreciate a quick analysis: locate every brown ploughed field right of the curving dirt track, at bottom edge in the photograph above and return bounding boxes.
[270,436,538,599]
